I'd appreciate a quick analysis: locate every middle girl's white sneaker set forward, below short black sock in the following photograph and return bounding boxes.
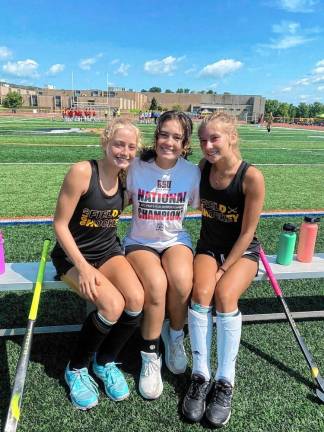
[139,351,163,399]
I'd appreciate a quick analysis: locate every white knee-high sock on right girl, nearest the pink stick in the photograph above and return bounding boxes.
[215,309,242,385]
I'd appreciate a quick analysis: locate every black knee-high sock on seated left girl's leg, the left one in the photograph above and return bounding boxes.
[70,311,114,369]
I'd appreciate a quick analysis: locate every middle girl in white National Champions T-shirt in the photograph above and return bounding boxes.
[124,111,200,399]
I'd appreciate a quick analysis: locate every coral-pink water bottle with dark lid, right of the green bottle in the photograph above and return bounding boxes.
[297,216,320,262]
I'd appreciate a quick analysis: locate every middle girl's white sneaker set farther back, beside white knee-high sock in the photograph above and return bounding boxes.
[161,320,188,375]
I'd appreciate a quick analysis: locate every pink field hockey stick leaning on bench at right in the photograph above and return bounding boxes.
[260,248,324,403]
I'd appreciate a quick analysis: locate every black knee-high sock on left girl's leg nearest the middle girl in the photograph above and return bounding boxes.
[97,311,142,365]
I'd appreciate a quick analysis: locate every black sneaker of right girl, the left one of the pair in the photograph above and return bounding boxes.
[182,374,212,422]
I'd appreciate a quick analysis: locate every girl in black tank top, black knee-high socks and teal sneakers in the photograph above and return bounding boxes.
[51,119,144,410]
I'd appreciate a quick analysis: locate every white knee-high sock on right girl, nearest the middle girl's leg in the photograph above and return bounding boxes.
[188,304,213,380]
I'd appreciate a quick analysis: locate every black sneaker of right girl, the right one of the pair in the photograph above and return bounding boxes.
[206,380,233,427]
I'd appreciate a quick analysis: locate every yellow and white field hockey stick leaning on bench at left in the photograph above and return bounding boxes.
[4,240,50,432]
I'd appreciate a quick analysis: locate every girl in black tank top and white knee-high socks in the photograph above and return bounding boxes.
[182,113,265,427]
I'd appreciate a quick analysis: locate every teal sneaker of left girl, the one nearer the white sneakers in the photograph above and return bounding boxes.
[92,355,129,401]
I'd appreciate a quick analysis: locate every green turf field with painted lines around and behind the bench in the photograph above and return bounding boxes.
[0,119,324,432]
